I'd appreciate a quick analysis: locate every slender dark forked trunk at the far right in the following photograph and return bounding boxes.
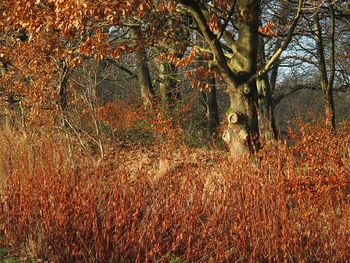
[313,1,335,130]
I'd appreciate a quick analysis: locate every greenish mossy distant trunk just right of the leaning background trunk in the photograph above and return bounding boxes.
[159,62,181,109]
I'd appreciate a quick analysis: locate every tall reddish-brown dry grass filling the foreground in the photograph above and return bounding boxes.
[0,122,350,262]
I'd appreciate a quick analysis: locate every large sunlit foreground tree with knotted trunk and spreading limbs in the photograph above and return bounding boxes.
[179,0,303,157]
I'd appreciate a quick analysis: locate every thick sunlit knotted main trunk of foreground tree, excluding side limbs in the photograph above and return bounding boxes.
[223,0,259,159]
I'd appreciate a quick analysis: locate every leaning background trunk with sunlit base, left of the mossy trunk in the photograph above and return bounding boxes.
[131,26,155,109]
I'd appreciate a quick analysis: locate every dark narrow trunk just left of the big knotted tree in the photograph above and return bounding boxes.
[201,78,219,139]
